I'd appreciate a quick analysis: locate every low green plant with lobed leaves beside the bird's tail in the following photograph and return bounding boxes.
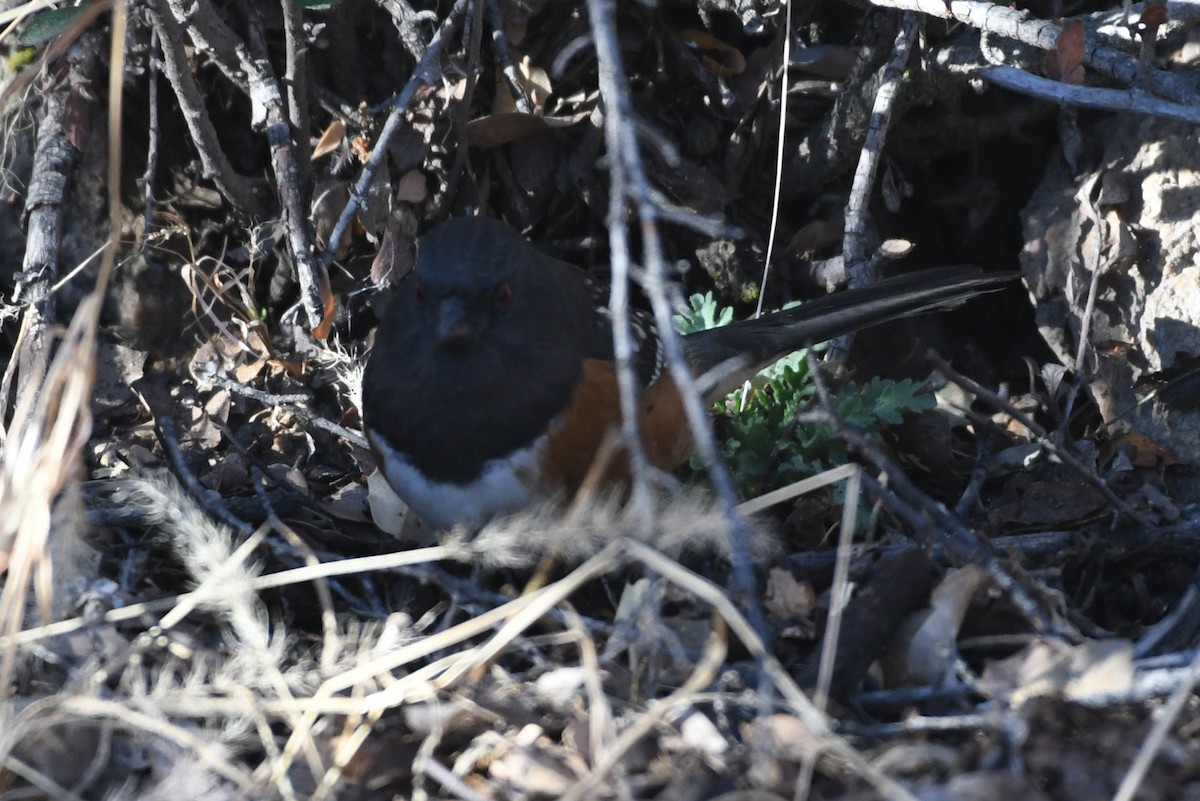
[676,293,935,496]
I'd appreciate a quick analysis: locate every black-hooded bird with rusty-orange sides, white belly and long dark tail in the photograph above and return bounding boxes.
[361,217,1010,531]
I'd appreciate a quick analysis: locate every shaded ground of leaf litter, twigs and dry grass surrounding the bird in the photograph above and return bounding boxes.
[0,0,1200,801]
